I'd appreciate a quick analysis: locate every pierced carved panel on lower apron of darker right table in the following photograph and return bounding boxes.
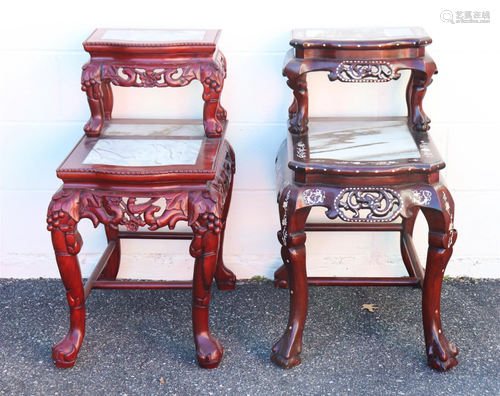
[334,187,402,222]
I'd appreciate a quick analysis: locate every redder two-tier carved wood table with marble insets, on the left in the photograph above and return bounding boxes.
[47,29,236,368]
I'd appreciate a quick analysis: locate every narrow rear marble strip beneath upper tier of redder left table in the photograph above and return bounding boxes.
[101,123,205,137]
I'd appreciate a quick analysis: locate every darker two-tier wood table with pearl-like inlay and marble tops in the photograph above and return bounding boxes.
[271,28,458,371]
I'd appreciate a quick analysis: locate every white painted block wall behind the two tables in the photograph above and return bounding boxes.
[0,0,500,279]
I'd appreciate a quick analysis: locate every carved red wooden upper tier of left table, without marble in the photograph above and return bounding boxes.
[82,29,227,138]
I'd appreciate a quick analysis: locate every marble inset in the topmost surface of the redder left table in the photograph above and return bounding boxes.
[100,29,206,43]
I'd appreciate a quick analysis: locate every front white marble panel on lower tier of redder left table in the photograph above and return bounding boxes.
[83,139,202,166]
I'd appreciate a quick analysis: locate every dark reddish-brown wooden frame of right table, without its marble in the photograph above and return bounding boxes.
[271,30,458,371]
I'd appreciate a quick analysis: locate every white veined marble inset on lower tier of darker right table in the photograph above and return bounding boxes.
[309,120,420,161]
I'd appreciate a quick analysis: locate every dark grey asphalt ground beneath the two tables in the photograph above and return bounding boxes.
[0,279,500,396]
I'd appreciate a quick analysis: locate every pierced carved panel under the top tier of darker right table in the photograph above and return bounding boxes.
[336,61,400,82]
